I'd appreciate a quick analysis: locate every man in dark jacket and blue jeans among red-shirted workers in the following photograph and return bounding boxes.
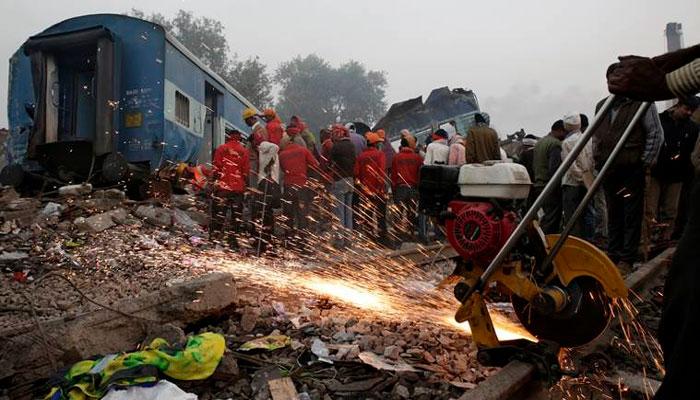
[329,125,355,248]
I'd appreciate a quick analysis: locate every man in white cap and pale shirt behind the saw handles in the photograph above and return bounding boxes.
[561,113,595,241]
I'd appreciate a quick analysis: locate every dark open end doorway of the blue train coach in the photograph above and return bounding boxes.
[24,27,119,165]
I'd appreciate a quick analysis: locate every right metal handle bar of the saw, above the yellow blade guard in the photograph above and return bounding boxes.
[540,102,651,270]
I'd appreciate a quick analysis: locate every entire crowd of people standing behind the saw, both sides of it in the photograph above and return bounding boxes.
[195,97,700,273]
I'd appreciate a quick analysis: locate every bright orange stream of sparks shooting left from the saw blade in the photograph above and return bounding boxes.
[192,239,536,340]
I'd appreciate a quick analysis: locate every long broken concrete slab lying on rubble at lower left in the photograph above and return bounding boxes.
[0,273,236,398]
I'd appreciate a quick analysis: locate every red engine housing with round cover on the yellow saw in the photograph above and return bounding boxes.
[445,200,518,265]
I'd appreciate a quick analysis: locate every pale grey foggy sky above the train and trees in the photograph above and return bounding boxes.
[0,0,700,136]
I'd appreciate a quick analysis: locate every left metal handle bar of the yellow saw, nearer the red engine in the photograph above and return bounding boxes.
[460,94,615,302]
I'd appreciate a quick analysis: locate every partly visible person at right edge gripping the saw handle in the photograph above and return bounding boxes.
[608,41,700,400]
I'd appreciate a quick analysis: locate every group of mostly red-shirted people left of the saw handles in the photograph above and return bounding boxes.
[200,108,502,254]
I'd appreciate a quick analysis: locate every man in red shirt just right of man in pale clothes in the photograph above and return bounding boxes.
[279,124,319,251]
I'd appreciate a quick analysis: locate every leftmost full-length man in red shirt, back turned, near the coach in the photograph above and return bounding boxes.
[209,129,250,250]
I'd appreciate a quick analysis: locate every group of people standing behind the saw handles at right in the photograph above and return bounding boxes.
[525,96,700,273]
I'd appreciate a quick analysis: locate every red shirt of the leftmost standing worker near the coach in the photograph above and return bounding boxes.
[214,139,250,193]
